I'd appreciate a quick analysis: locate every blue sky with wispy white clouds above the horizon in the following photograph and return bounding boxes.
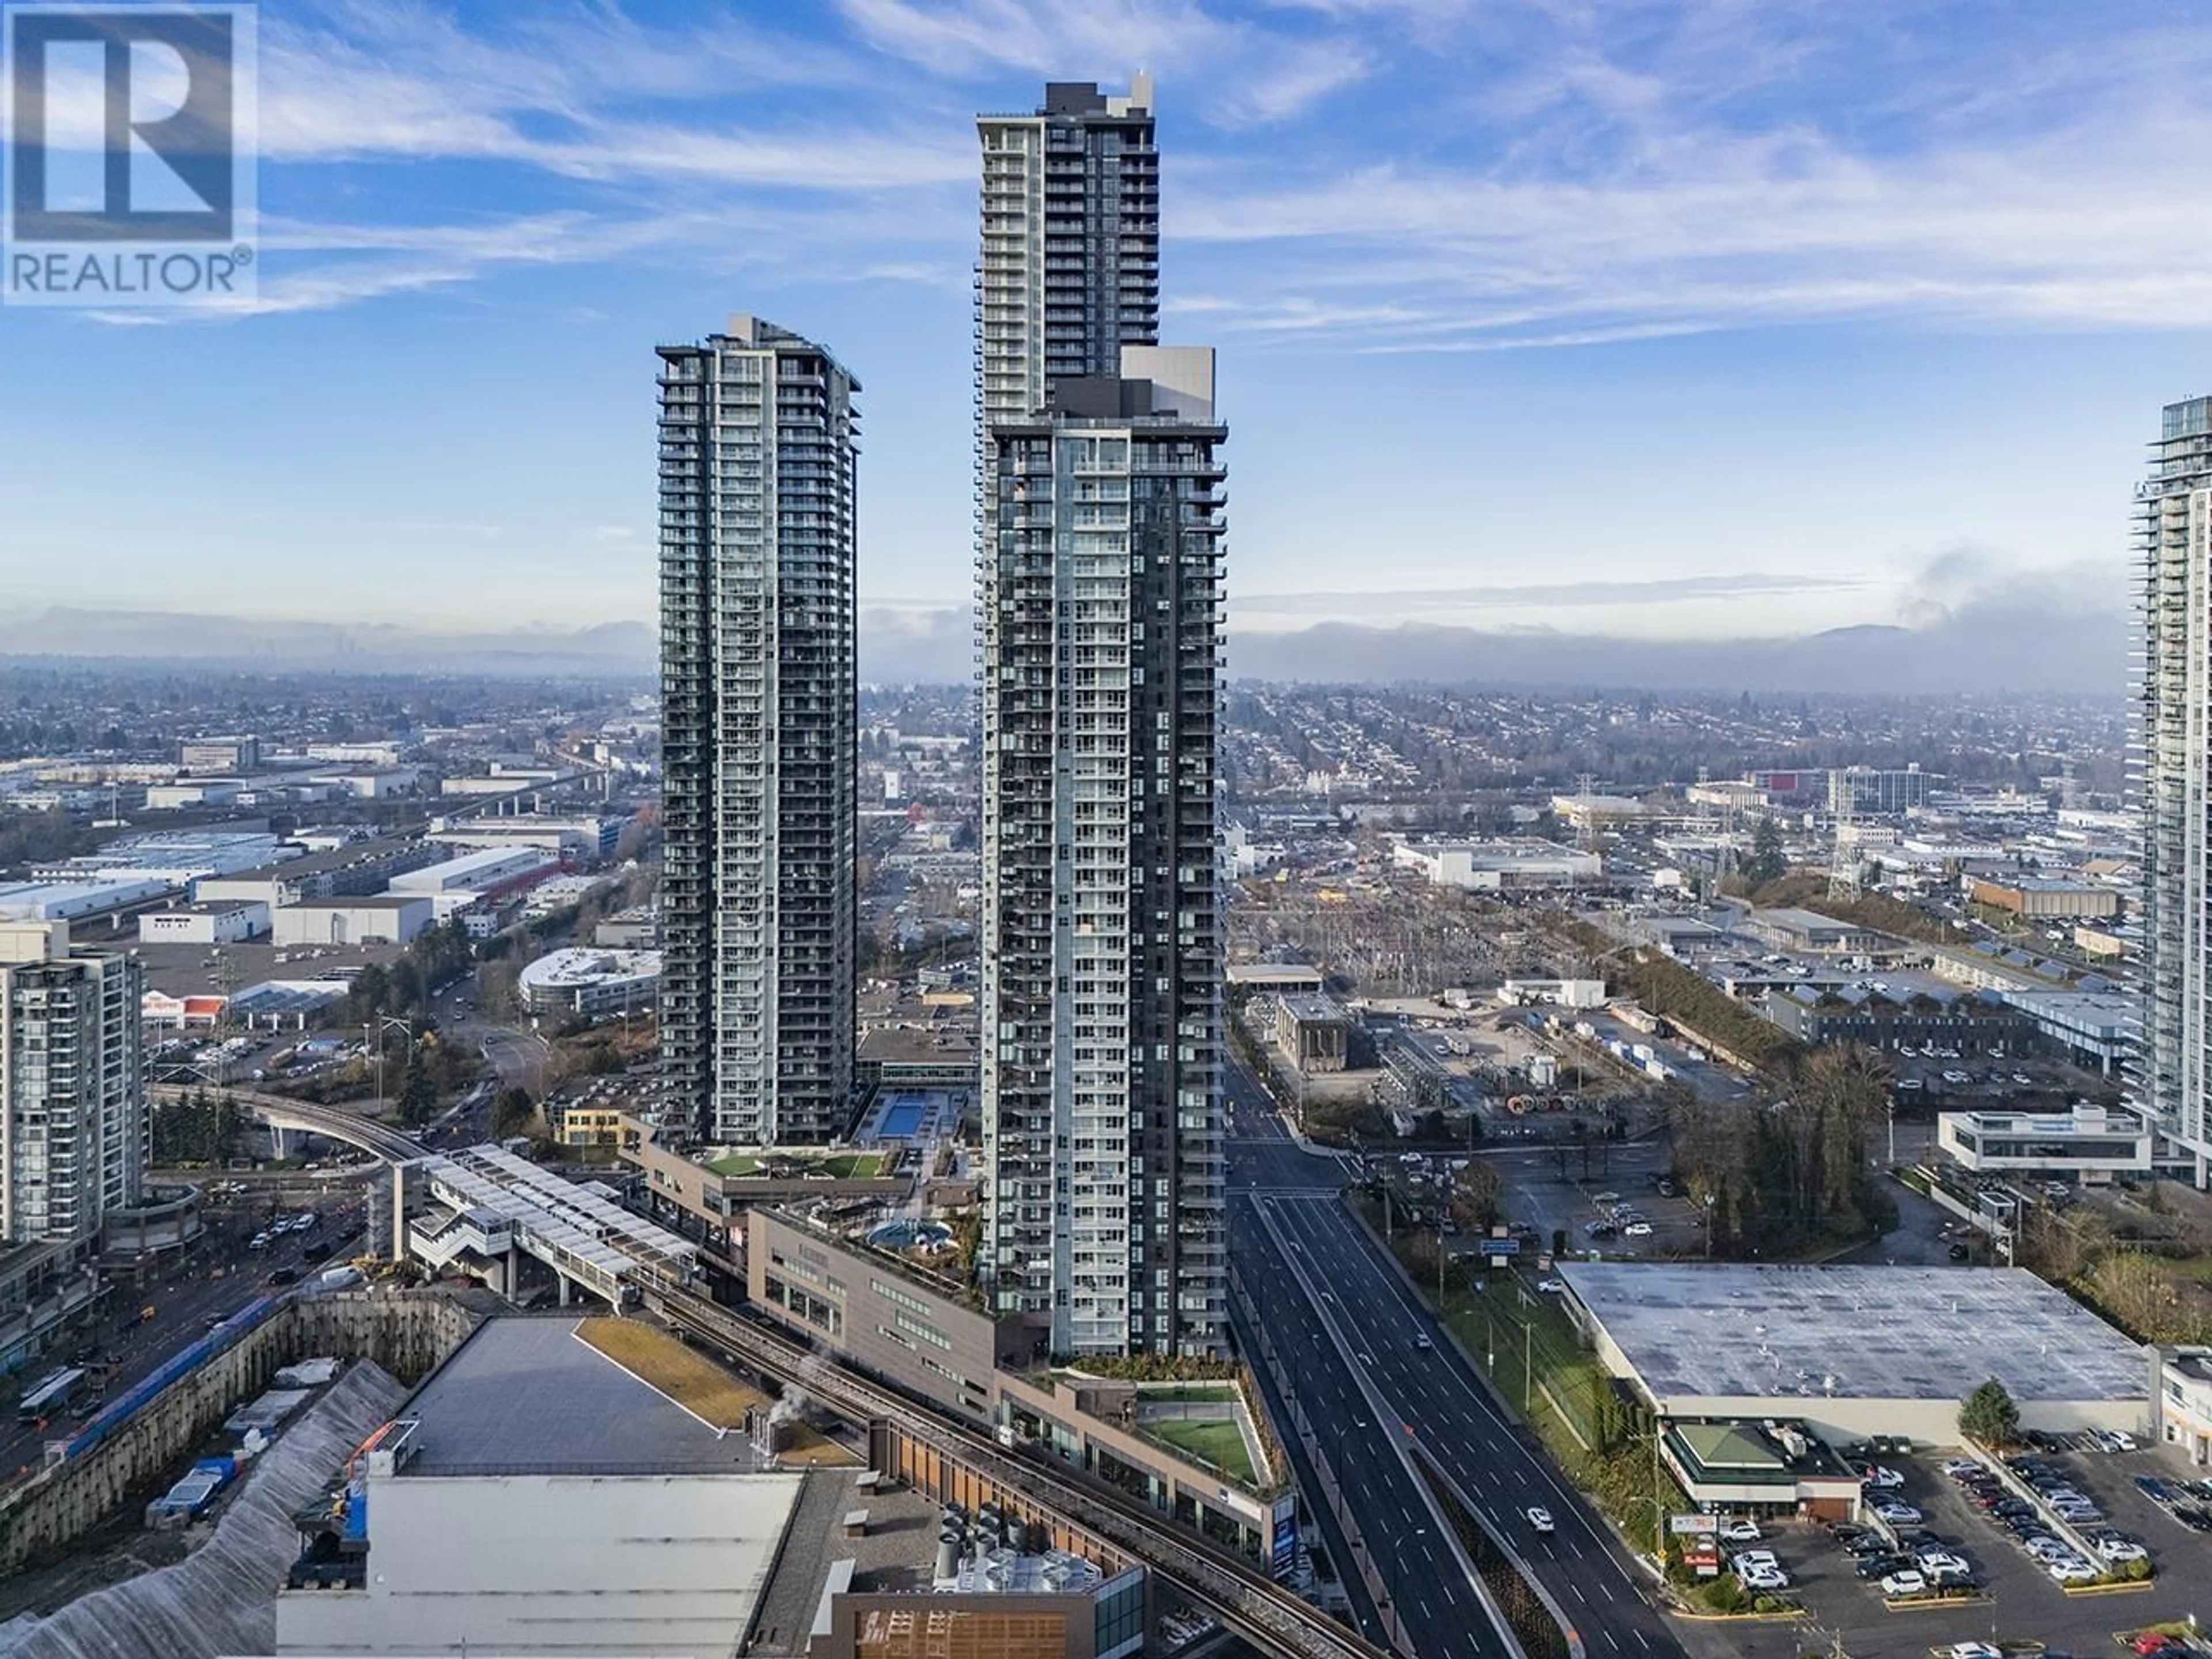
[0,0,2212,637]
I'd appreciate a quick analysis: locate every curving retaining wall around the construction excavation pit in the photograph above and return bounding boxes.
[0,1290,480,1573]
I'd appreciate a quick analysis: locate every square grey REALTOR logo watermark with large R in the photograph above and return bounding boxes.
[0,2,256,308]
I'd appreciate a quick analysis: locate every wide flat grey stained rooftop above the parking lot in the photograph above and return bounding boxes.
[1559,1261,2150,1403]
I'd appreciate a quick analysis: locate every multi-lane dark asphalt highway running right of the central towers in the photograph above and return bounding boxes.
[1230,1066,1683,1659]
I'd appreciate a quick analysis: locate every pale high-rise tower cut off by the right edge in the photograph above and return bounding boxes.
[2130,398,2212,1185]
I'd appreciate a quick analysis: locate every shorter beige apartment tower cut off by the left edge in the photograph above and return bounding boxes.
[0,922,148,1248]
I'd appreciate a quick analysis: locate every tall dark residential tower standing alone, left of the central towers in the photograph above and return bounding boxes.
[659,316,861,1146]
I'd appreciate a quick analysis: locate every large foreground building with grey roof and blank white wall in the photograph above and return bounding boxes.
[276,1319,805,1659]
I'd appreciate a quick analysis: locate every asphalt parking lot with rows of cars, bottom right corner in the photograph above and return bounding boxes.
[1681,1449,2212,1659]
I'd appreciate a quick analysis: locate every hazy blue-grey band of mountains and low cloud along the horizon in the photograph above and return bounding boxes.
[0,601,2133,697]
